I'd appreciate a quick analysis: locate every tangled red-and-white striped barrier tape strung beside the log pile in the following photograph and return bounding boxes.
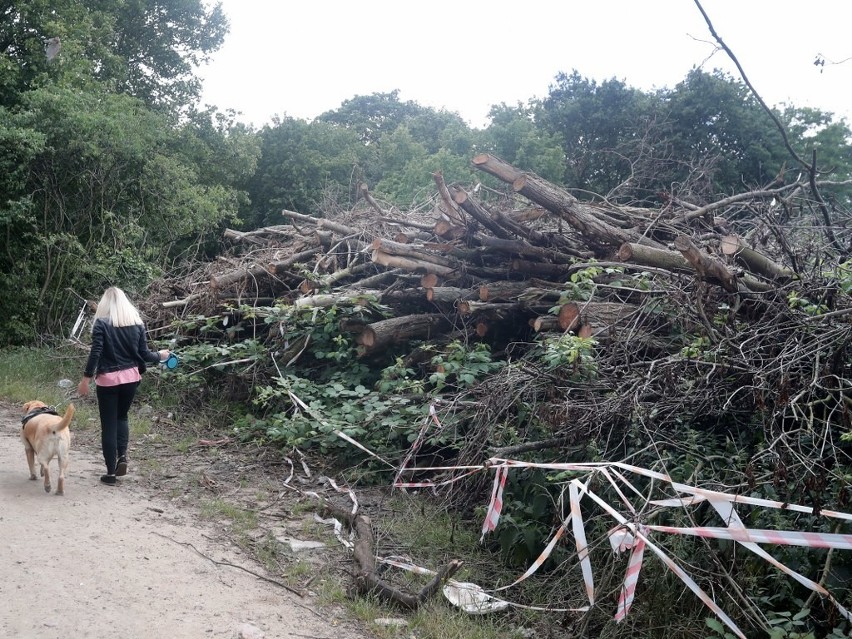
[328,416,852,639]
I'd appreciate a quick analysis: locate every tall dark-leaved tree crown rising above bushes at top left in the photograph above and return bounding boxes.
[0,0,228,111]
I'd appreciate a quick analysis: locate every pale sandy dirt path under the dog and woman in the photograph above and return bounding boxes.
[0,405,368,639]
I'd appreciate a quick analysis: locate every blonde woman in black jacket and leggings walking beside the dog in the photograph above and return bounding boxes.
[77,286,169,485]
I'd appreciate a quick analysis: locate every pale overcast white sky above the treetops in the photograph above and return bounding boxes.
[201,0,852,127]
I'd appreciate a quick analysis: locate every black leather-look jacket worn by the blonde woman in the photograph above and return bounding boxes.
[83,319,160,377]
